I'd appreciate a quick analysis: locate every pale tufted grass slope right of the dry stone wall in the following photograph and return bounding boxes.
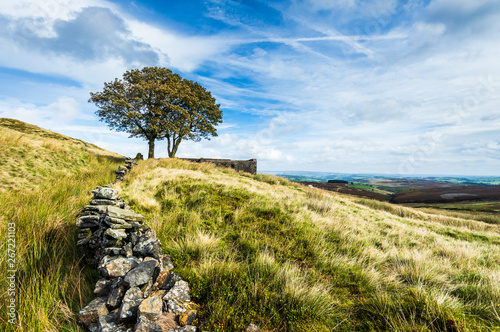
[118,160,500,331]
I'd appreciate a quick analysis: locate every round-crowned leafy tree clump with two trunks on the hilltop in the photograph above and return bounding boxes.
[89,67,222,158]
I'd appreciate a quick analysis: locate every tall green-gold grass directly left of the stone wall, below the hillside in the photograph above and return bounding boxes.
[0,155,119,331]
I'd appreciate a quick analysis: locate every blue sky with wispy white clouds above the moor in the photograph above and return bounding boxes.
[0,0,500,176]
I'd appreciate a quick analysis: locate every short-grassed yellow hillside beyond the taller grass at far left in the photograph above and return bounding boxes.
[0,118,124,191]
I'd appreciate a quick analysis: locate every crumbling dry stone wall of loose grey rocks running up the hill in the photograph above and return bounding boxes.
[76,159,196,332]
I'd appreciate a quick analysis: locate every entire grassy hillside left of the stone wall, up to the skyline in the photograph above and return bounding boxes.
[0,119,123,331]
